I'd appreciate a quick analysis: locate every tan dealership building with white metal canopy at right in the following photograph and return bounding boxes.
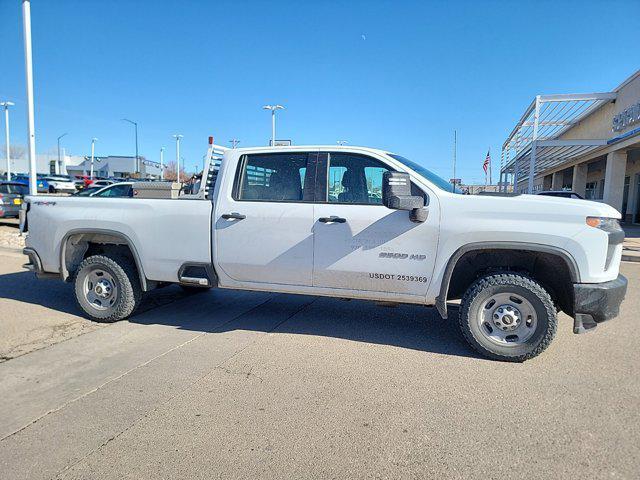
[500,70,640,223]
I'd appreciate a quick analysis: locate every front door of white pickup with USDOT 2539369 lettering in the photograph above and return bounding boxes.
[313,152,439,297]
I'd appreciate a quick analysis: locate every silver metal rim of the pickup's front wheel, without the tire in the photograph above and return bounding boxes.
[477,293,538,347]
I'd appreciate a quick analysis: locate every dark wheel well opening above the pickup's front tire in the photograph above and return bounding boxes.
[446,249,574,315]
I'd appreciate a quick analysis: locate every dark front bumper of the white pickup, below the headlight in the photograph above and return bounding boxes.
[573,275,627,333]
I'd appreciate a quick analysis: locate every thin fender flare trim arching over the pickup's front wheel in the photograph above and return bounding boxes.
[436,242,580,318]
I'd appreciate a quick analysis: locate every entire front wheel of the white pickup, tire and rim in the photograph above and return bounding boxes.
[459,273,557,362]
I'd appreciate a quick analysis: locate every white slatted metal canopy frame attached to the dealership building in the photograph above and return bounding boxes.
[500,92,616,193]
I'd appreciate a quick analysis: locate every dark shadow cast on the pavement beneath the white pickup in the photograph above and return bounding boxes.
[0,272,480,358]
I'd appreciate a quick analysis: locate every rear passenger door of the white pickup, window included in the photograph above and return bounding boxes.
[213,152,317,286]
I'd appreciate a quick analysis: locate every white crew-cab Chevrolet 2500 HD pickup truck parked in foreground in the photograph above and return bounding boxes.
[23,146,627,361]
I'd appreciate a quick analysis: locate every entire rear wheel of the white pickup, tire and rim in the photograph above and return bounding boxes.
[75,255,142,323]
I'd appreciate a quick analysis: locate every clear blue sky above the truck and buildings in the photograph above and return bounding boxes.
[0,0,640,182]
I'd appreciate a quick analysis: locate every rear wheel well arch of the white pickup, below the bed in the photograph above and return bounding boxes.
[61,232,147,291]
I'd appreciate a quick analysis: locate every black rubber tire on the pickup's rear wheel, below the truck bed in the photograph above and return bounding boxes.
[74,255,142,323]
